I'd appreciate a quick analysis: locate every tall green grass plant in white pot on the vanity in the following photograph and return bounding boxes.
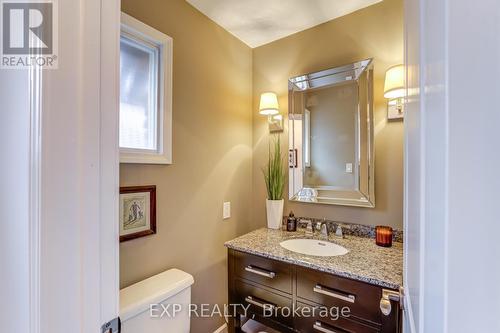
[263,135,285,229]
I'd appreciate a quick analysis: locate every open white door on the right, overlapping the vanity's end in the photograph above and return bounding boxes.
[404,0,500,333]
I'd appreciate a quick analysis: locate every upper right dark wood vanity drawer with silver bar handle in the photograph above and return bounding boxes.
[297,267,382,324]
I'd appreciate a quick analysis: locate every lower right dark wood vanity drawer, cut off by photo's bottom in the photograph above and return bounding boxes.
[294,303,380,333]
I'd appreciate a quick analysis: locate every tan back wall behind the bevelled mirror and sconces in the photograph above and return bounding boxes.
[253,0,403,229]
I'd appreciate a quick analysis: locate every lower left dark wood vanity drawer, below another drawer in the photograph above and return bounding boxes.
[235,280,293,325]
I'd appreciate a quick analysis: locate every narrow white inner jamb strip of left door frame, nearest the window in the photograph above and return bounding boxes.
[100,0,121,323]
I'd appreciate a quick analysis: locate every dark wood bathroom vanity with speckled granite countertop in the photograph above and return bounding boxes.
[225,228,403,333]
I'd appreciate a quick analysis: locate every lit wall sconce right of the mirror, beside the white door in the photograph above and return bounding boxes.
[384,65,405,120]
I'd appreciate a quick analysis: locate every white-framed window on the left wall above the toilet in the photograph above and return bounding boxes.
[120,13,172,164]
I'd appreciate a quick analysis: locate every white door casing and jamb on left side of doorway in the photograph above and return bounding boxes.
[41,0,120,333]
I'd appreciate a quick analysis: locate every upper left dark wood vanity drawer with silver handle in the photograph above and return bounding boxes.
[234,252,292,294]
